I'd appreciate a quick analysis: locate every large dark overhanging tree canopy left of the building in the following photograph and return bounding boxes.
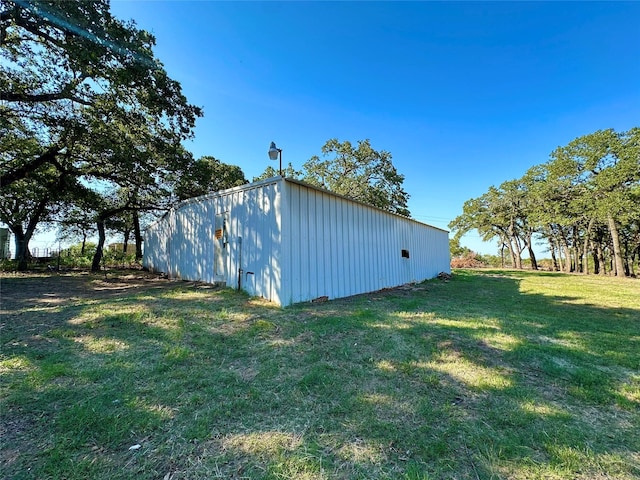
[0,0,202,270]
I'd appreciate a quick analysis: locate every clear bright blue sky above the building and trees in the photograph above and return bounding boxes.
[69,0,640,254]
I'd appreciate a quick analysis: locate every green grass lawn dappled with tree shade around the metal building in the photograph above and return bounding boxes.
[0,270,640,480]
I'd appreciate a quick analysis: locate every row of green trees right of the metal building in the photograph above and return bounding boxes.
[449,127,640,276]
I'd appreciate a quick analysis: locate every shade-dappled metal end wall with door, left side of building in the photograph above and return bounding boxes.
[143,179,282,303]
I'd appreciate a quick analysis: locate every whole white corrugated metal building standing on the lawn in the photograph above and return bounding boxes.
[143,177,450,306]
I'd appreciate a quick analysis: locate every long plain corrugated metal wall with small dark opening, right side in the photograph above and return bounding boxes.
[282,181,450,305]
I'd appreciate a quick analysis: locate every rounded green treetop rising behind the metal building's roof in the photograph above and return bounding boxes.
[302,138,411,217]
